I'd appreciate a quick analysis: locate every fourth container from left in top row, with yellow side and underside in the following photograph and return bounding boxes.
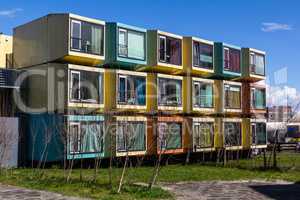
[183,37,214,77]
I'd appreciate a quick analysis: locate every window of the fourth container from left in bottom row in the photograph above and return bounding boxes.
[193,122,214,150]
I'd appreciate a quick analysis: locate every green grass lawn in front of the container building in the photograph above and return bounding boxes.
[0,153,300,200]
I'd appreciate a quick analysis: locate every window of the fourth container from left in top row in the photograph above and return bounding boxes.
[193,41,214,69]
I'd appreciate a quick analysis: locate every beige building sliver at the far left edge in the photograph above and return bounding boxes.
[0,33,12,68]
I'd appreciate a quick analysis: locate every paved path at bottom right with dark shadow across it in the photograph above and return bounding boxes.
[163,181,300,200]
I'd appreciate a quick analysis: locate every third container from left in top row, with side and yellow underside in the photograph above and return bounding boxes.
[138,30,182,74]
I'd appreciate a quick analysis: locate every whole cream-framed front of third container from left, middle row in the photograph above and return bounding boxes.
[157,74,183,111]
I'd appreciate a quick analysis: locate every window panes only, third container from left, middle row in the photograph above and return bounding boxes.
[158,78,182,106]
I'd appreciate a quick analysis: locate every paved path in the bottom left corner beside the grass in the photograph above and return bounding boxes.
[0,184,88,200]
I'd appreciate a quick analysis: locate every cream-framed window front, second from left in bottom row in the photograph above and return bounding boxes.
[116,117,147,156]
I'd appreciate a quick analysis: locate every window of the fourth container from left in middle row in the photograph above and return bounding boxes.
[194,81,213,108]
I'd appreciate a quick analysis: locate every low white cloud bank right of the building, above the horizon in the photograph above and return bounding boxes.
[267,85,300,107]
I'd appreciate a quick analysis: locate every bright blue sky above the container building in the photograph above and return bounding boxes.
[0,0,300,104]
